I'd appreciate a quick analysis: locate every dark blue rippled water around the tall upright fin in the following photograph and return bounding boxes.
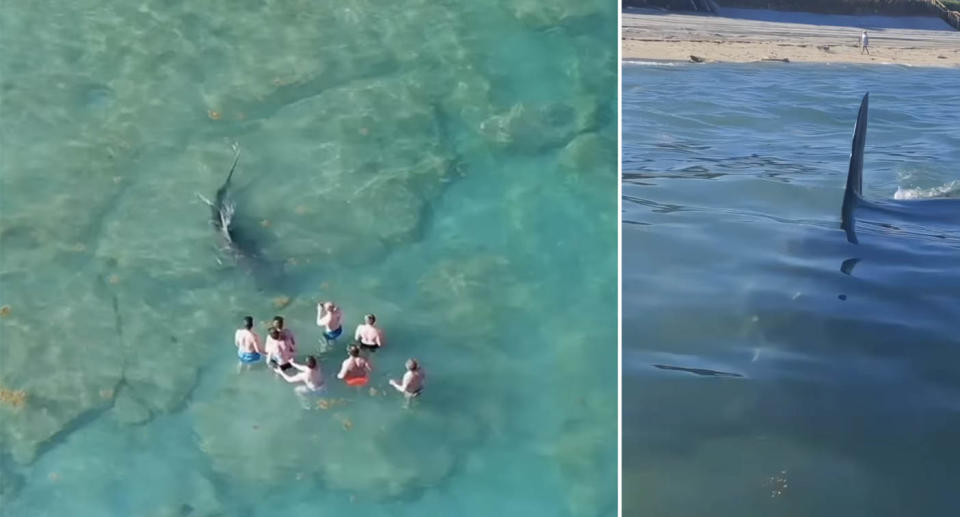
[622,63,960,517]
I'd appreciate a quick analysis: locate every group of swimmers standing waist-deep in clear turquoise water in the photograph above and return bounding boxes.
[234,302,426,402]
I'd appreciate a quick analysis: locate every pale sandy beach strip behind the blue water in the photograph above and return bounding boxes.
[622,9,960,67]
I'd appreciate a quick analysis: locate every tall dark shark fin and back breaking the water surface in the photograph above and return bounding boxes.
[840,93,960,245]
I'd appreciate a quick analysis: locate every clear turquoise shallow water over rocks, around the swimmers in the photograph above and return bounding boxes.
[0,0,617,516]
